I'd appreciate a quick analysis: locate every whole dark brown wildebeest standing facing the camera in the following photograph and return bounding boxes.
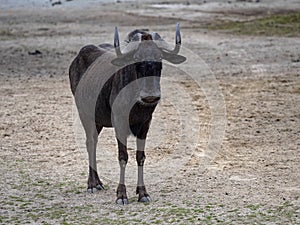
[69,24,185,204]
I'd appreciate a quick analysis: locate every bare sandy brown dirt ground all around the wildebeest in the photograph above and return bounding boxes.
[0,0,300,224]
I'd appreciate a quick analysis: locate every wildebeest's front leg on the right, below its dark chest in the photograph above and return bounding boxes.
[136,138,151,202]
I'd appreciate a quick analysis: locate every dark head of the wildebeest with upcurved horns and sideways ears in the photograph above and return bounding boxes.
[111,24,186,104]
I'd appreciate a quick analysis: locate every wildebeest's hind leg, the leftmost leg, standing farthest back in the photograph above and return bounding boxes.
[86,125,104,193]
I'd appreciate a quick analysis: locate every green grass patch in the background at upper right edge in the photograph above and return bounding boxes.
[208,12,300,37]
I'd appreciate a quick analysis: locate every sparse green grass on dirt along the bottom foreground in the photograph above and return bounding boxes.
[0,161,299,224]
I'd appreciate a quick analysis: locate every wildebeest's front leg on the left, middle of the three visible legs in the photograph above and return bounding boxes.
[116,139,129,205]
